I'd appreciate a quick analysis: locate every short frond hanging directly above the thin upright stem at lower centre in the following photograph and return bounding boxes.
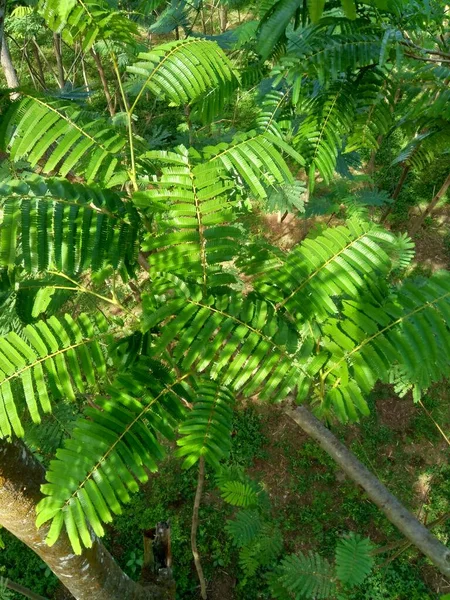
[175,382,234,469]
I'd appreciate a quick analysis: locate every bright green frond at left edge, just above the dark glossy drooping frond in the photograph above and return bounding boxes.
[0,94,128,187]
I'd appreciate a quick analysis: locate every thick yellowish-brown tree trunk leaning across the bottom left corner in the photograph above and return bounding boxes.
[0,440,173,600]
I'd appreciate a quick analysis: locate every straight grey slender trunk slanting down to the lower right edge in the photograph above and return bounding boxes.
[286,406,450,577]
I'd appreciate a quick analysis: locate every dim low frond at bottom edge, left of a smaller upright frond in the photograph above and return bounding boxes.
[279,552,336,599]
